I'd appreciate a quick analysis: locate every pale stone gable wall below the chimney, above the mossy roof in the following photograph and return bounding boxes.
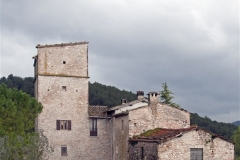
[129,103,190,137]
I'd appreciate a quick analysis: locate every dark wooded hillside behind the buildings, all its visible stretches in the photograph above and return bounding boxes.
[0,74,237,139]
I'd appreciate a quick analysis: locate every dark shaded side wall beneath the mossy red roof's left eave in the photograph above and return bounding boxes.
[128,141,158,160]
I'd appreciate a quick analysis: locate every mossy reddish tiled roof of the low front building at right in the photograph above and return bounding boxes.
[129,126,233,143]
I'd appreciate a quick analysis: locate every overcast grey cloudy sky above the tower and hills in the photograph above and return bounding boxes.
[0,0,240,122]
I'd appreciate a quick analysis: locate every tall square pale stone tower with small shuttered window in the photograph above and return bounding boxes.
[34,42,89,160]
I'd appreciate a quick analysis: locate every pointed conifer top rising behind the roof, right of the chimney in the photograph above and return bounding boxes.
[159,82,180,108]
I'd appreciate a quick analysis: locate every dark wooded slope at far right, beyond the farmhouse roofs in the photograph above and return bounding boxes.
[190,113,237,139]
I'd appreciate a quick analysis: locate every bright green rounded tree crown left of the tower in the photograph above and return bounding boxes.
[0,85,42,136]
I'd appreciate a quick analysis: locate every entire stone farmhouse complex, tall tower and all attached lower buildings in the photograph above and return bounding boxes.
[33,42,234,160]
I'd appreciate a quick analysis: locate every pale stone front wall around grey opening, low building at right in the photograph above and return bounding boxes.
[158,130,234,160]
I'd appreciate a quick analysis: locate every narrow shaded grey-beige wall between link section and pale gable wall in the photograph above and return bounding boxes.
[113,115,129,160]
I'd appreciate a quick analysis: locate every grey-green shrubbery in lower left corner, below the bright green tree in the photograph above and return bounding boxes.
[0,131,53,160]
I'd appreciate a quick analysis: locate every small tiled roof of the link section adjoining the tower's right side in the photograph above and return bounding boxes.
[88,106,108,117]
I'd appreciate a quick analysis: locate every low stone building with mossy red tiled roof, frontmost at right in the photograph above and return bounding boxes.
[129,126,234,160]
